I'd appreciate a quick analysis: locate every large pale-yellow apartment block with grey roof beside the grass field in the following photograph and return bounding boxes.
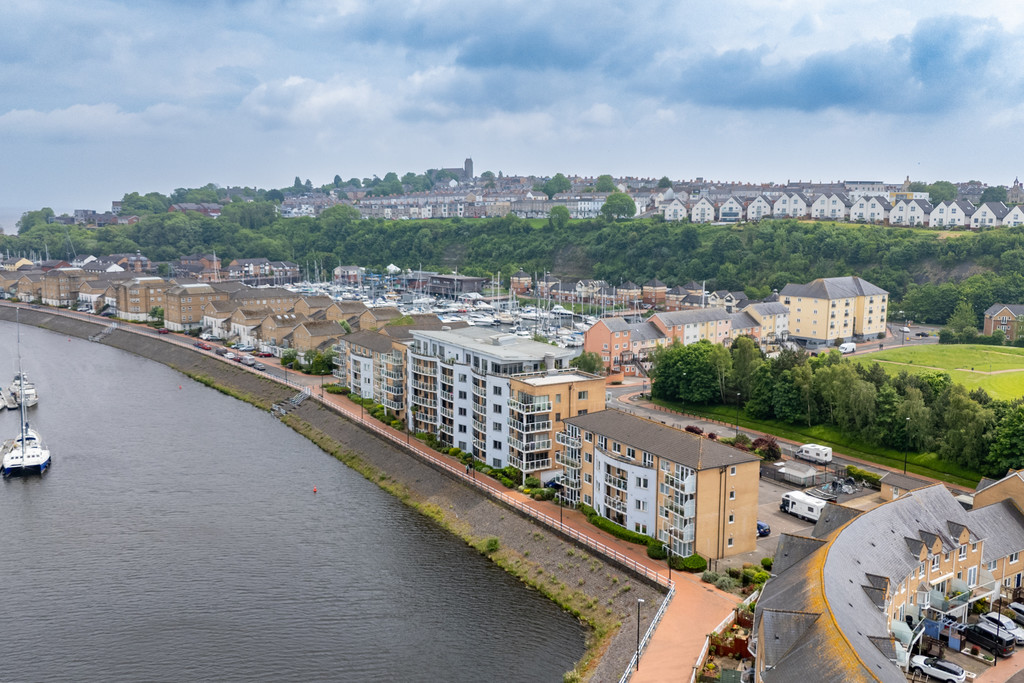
[779,276,889,344]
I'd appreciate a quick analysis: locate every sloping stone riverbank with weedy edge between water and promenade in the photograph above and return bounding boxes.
[0,307,664,681]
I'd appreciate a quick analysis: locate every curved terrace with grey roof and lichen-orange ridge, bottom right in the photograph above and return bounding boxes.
[754,483,1024,683]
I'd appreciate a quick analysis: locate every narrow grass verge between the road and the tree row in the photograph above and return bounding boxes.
[654,399,981,489]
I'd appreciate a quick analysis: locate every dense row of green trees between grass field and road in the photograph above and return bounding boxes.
[651,337,1024,476]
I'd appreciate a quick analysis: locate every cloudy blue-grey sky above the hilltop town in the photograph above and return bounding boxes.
[0,0,1024,233]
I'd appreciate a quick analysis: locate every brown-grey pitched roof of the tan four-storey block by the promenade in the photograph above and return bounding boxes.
[565,411,759,470]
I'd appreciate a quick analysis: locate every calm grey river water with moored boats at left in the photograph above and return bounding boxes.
[0,323,585,681]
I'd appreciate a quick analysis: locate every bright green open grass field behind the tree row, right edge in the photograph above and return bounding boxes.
[852,344,1024,399]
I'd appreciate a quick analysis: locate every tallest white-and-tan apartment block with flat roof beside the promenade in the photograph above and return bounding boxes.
[406,327,585,472]
